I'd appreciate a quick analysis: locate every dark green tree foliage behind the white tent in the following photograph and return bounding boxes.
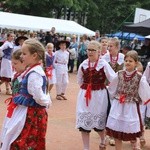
[0,0,150,33]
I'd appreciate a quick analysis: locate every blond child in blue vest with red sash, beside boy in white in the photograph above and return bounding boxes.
[46,43,56,92]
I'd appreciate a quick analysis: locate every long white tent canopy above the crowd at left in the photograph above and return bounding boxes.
[0,12,95,35]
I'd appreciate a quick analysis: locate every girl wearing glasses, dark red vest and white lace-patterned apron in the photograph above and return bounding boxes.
[76,41,115,150]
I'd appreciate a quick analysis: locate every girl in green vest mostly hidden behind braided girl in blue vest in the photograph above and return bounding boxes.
[1,50,25,150]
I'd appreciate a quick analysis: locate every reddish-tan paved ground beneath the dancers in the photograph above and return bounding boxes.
[0,73,150,150]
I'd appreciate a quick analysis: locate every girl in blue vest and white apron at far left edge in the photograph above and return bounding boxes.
[0,33,14,94]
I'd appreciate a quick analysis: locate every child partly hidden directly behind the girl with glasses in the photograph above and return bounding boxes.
[100,37,109,56]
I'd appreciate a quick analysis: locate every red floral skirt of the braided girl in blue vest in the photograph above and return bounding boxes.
[10,107,48,150]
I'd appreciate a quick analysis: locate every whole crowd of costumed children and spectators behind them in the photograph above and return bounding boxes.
[0,28,150,150]
